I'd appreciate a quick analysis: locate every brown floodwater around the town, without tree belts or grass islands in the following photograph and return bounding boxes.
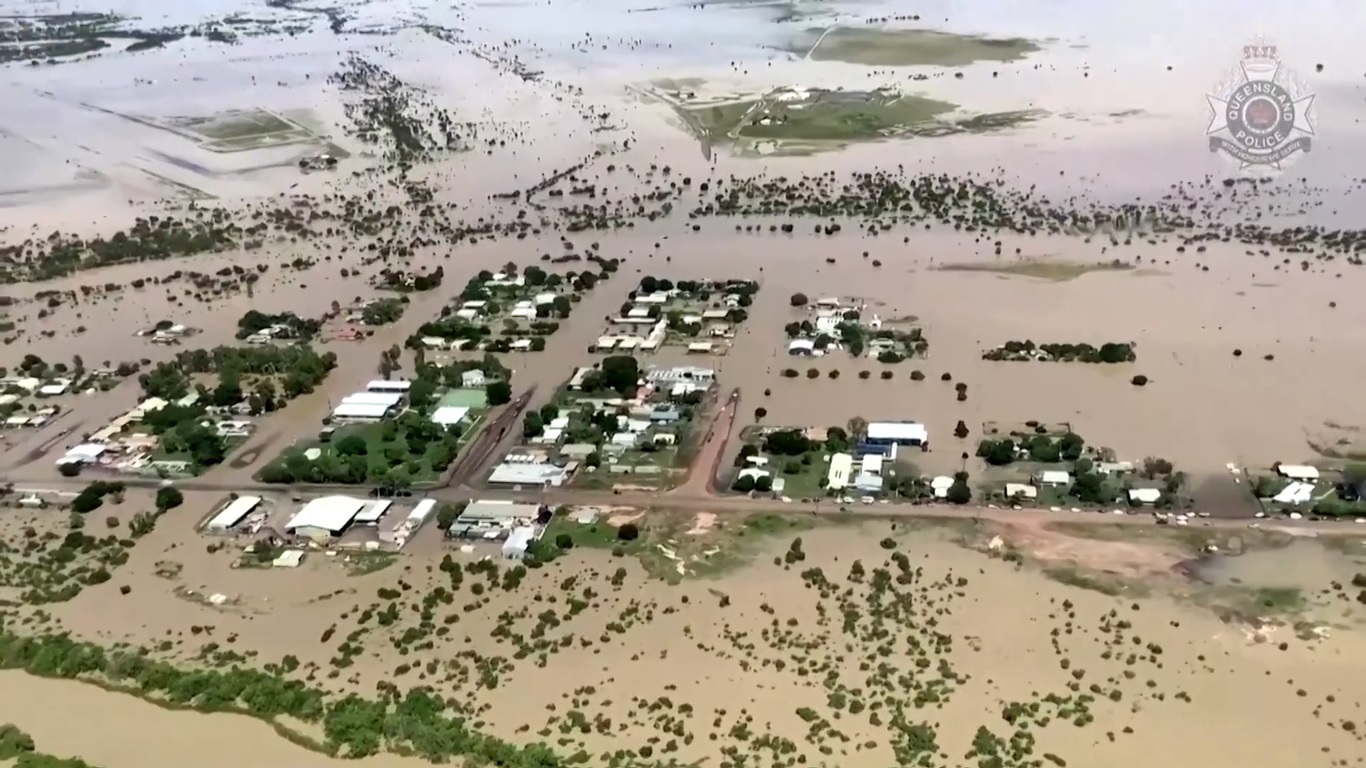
[8,0,1366,768]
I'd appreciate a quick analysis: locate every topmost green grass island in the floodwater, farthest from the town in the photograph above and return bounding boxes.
[788,27,1042,67]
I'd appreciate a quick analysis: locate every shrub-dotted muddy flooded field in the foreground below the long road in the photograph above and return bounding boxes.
[0,497,1366,768]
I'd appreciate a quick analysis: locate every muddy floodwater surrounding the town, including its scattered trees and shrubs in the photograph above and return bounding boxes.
[8,0,1366,768]
